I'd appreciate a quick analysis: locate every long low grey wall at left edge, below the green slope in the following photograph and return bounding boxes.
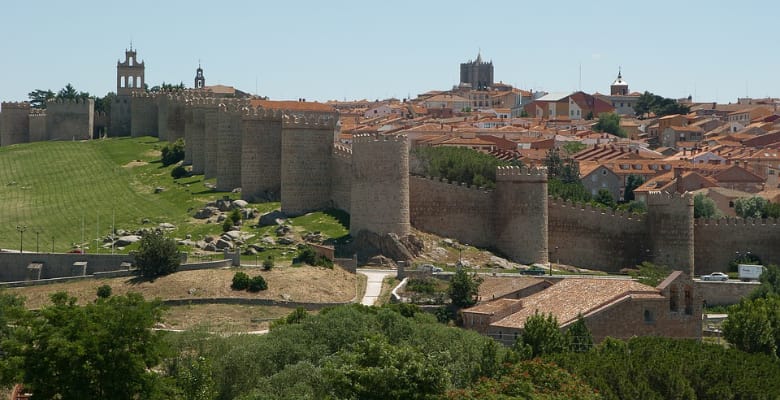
[0,253,133,282]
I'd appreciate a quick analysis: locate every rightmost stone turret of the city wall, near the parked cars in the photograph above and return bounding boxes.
[647,191,694,276]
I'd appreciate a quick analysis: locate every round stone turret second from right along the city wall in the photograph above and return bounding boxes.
[493,167,548,263]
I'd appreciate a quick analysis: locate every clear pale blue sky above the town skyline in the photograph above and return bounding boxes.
[0,0,780,103]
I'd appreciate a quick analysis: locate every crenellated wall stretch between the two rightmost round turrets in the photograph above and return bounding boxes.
[548,198,650,272]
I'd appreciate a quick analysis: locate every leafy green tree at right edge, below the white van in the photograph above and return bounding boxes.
[723,295,780,357]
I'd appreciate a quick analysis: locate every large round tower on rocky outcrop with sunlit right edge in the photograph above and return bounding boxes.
[349,135,411,237]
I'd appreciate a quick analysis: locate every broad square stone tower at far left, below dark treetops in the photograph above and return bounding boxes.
[46,99,95,140]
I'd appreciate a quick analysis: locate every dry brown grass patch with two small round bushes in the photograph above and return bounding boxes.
[10,267,362,308]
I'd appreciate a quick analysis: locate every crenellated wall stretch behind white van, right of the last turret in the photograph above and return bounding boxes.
[693,218,780,275]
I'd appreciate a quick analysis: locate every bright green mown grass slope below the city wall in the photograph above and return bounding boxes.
[0,137,347,253]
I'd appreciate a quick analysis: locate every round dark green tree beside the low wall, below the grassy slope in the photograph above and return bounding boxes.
[135,232,181,278]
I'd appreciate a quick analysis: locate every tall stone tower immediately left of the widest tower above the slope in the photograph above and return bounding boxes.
[241,107,282,201]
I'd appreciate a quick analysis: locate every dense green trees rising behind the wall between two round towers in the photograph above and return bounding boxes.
[411,146,509,188]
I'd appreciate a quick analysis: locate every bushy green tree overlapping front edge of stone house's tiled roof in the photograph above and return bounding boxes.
[514,310,569,359]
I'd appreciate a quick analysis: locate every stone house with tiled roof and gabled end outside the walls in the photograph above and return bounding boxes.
[462,271,702,345]
